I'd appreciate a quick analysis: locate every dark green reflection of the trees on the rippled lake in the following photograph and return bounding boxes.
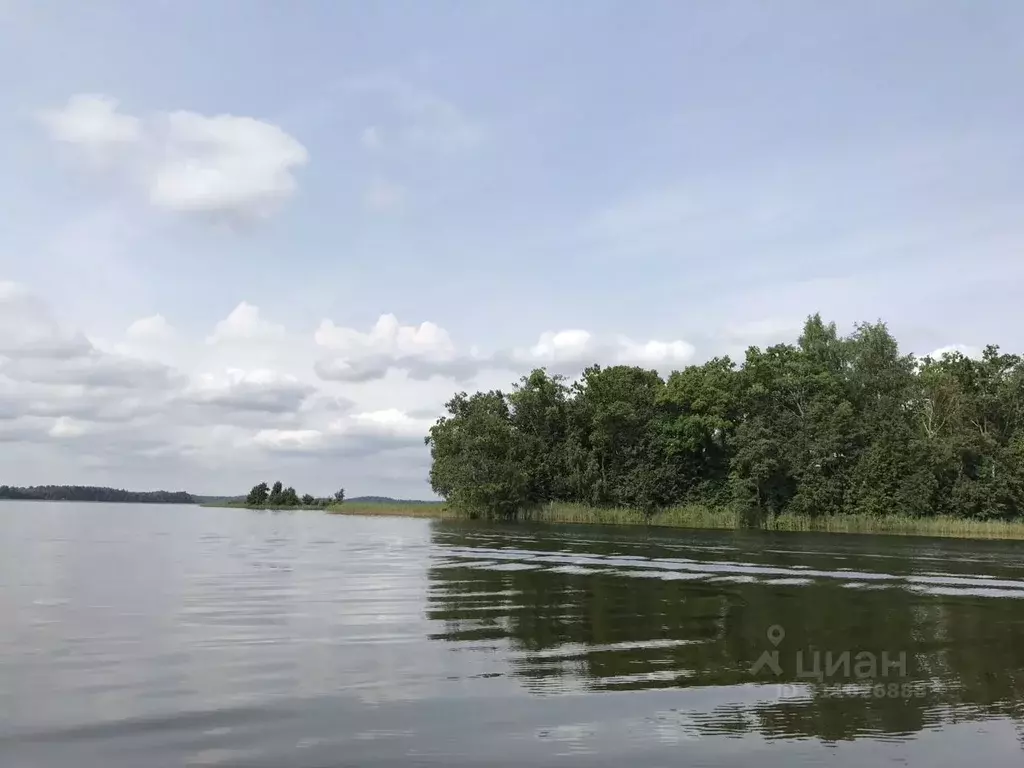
[428,535,1024,740]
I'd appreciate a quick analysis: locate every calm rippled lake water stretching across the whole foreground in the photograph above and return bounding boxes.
[0,502,1024,768]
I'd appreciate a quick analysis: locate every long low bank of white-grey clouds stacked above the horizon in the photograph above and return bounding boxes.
[0,283,737,497]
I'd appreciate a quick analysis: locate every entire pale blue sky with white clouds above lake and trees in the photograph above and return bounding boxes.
[0,0,1024,498]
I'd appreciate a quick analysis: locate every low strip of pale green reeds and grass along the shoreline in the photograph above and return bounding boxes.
[330,504,1024,540]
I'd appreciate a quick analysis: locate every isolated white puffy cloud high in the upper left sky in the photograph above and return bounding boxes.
[38,94,309,219]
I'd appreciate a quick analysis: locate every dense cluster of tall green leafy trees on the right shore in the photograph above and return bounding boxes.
[426,314,1024,523]
